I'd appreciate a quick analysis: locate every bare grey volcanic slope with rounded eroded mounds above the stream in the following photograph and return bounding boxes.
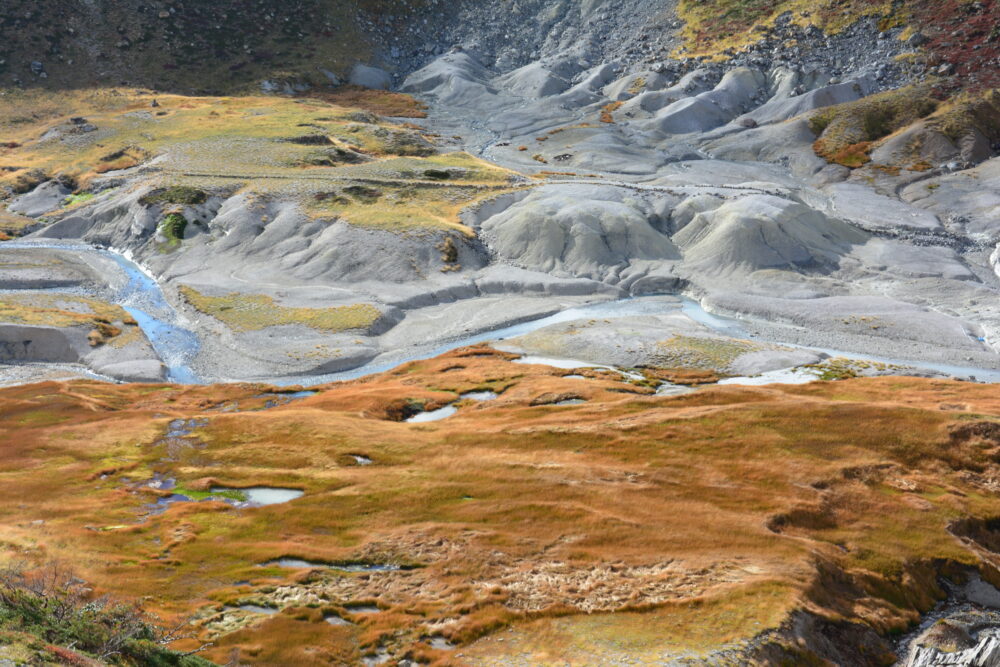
[1,0,1000,379]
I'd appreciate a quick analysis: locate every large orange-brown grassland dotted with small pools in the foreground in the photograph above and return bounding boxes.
[0,348,1000,665]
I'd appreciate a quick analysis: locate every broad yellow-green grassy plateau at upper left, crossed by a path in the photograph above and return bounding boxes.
[0,91,514,234]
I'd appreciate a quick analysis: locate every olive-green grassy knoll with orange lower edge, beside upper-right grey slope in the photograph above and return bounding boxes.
[809,86,939,168]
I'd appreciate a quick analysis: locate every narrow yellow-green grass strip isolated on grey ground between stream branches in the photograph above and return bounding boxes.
[180,285,381,333]
